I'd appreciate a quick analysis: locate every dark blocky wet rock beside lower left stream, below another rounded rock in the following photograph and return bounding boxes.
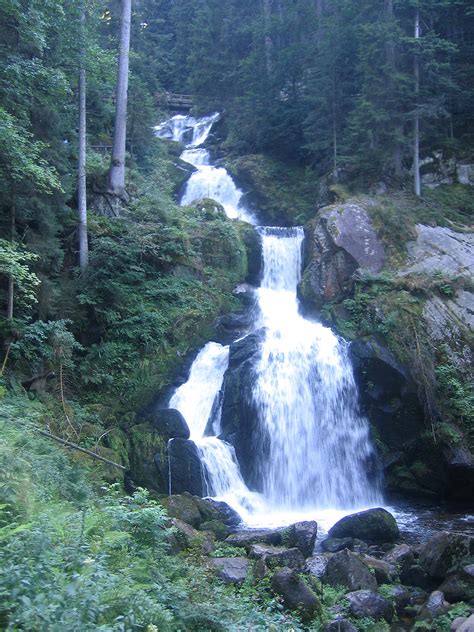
[168,439,205,496]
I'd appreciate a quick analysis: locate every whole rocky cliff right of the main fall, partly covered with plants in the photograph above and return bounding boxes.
[301,199,474,498]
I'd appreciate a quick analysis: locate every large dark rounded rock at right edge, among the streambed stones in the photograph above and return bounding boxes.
[419,532,474,579]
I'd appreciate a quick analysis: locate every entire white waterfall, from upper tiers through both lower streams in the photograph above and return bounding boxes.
[157,115,383,526]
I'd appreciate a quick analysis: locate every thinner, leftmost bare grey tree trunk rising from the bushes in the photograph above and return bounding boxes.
[78,1,89,270]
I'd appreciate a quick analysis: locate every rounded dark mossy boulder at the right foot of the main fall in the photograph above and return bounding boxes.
[329,508,400,542]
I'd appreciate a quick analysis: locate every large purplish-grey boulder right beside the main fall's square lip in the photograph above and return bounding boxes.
[301,202,385,308]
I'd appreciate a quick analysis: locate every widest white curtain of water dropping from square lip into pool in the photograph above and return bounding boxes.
[254,228,380,509]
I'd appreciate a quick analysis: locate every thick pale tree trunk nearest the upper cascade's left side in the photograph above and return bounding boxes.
[108,0,132,204]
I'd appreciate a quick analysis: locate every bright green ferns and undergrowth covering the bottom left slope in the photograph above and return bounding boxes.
[0,397,299,632]
